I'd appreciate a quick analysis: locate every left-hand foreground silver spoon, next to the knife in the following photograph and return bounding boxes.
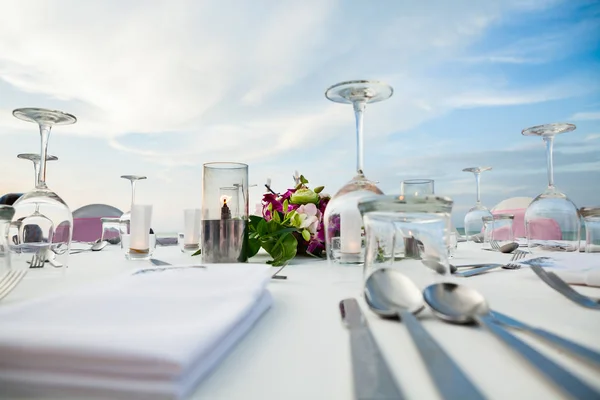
[365,268,485,400]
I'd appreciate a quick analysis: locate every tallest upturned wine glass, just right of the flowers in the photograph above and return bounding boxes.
[324,80,394,264]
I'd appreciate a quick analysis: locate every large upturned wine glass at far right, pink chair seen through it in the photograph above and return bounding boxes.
[521,123,581,251]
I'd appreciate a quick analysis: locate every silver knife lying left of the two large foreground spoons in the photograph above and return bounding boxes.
[340,298,405,400]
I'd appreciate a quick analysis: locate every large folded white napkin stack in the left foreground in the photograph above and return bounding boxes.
[0,264,271,399]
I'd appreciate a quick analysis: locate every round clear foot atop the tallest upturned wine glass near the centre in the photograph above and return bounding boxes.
[325,80,394,104]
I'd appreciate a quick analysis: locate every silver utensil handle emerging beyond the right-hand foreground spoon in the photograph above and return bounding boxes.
[491,311,600,367]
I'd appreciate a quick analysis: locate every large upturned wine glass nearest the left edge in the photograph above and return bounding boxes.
[11,108,77,268]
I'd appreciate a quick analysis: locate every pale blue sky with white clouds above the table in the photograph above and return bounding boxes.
[0,0,600,231]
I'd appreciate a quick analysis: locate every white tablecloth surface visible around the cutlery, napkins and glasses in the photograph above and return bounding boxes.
[0,243,600,400]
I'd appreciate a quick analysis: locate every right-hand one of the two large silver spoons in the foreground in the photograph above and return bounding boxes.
[423,282,600,400]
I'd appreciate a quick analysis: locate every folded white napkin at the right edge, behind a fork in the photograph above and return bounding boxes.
[519,252,600,287]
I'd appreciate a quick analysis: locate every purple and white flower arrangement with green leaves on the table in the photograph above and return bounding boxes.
[248,175,330,266]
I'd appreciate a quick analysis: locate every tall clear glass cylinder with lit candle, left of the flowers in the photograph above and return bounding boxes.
[201,162,248,263]
